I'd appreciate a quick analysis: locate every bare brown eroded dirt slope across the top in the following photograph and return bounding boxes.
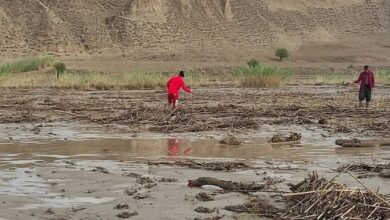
[0,0,390,58]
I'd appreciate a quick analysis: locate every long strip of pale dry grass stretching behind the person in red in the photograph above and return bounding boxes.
[0,70,210,90]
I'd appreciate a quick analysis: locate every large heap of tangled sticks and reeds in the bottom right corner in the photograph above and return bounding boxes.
[281,173,390,219]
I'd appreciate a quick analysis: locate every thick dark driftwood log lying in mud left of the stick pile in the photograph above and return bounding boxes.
[188,177,265,193]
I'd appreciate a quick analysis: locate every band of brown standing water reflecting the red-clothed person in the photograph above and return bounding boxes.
[0,138,390,169]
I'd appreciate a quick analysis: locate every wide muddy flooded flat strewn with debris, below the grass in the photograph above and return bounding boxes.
[0,87,390,220]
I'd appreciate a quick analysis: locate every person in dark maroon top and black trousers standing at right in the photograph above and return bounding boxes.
[354,66,375,109]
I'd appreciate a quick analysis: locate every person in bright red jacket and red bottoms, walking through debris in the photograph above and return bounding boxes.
[167,71,191,109]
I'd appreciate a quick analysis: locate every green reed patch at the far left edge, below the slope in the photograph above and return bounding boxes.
[0,57,54,75]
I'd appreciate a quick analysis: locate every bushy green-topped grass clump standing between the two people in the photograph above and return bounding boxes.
[235,63,293,87]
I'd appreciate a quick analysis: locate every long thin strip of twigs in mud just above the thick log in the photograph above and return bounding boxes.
[148,160,251,172]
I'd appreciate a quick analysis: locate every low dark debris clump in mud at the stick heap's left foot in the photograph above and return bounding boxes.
[225,199,283,219]
